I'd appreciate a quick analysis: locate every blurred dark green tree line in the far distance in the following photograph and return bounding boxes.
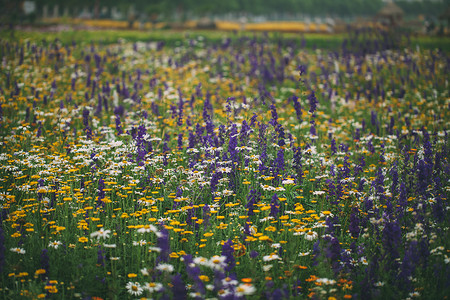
[0,0,450,18]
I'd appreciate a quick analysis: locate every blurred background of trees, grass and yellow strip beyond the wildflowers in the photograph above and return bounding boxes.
[0,0,450,35]
